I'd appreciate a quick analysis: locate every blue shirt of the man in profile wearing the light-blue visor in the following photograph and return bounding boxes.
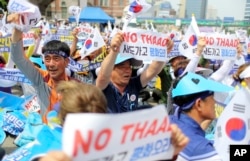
[170,113,221,160]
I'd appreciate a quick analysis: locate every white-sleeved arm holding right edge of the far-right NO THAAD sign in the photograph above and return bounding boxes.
[210,43,242,82]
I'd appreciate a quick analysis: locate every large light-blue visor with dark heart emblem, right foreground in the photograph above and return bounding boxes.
[172,72,234,98]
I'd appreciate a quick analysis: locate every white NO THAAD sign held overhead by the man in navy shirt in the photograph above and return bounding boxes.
[120,28,170,62]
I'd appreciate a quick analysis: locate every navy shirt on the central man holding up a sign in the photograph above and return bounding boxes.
[103,76,142,113]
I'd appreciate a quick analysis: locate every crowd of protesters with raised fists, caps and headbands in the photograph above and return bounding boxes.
[0,0,250,161]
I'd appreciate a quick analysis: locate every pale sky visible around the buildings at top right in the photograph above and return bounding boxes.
[168,0,246,20]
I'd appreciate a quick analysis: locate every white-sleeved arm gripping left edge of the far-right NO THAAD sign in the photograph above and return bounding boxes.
[183,37,206,74]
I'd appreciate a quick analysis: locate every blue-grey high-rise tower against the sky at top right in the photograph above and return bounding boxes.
[185,0,207,19]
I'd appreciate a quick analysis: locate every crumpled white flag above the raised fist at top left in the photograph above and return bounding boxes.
[7,0,41,32]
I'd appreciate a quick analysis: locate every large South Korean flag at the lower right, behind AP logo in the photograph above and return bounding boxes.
[214,88,250,161]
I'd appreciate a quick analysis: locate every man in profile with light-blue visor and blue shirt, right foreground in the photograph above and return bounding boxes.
[171,72,233,161]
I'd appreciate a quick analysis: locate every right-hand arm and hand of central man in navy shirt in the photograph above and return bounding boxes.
[140,40,174,87]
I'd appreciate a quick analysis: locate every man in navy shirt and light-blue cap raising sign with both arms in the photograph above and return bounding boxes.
[96,33,173,113]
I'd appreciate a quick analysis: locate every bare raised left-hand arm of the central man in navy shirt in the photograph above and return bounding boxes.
[96,33,123,89]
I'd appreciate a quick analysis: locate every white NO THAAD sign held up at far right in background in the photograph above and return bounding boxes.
[203,33,239,60]
